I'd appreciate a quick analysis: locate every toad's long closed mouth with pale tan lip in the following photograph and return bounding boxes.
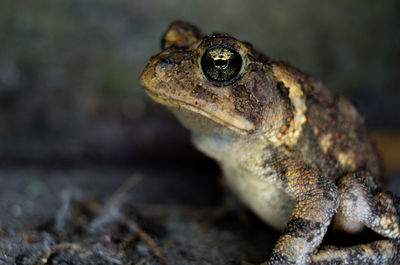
[144,88,254,135]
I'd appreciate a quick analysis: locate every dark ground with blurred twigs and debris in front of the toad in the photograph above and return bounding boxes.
[0,162,400,264]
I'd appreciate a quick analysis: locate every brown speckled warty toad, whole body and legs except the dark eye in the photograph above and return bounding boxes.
[140,22,400,264]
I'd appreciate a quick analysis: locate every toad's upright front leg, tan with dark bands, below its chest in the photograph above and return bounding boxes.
[265,161,338,265]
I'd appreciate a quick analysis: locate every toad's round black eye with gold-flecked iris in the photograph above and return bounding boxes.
[200,44,243,82]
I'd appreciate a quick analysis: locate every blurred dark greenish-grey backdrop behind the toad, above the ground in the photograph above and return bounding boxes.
[0,0,400,163]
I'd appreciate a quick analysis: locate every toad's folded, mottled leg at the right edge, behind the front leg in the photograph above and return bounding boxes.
[312,171,400,265]
